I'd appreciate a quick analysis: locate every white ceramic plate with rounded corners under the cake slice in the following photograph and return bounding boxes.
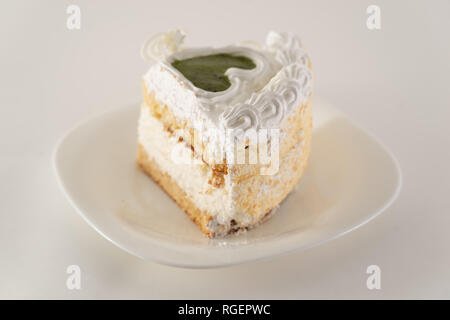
[54,98,401,268]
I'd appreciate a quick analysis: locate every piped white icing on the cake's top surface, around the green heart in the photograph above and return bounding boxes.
[142,30,312,131]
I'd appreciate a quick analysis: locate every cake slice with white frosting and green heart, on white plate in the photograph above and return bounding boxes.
[137,30,312,237]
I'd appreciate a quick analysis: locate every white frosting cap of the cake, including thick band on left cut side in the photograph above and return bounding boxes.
[142,30,312,132]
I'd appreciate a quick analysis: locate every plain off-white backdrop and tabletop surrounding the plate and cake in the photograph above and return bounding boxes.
[0,0,450,299]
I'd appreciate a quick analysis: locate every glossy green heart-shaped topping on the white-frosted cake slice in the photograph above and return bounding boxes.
[172,53,256,92]
